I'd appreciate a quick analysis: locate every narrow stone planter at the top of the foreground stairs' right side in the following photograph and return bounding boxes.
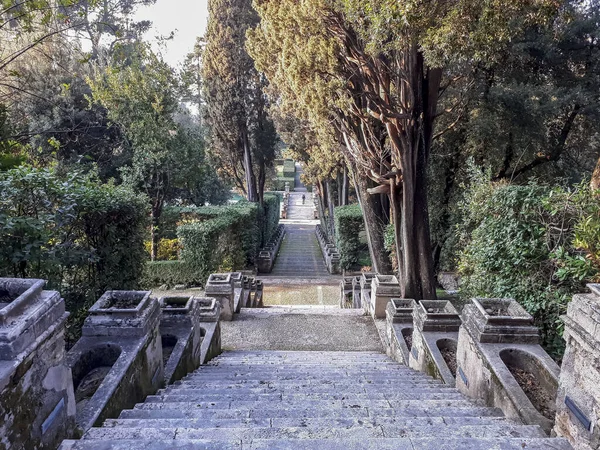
[385,298,416,365]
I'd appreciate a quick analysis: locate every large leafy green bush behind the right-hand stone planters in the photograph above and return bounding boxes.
[459,179,600,357]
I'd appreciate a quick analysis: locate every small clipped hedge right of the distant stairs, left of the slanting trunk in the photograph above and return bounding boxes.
[334,204,365,270]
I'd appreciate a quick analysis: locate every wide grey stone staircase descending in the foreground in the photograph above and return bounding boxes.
[61,351,571,450]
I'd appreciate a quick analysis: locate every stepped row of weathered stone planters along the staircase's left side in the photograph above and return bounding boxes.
[0,274,230,449]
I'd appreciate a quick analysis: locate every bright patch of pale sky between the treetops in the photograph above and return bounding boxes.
[135,0,208,67]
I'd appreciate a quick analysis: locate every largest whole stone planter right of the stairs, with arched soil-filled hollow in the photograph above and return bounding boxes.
[456,298,560,432]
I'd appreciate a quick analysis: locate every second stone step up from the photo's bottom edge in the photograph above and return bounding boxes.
[84,424,545,443]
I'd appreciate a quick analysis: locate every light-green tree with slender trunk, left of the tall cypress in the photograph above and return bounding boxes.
[88,45,180,260]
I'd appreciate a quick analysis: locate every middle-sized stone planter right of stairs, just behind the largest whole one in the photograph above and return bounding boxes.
[408,300,461,386]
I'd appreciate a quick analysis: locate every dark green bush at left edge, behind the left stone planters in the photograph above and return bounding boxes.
[0,166,148,342]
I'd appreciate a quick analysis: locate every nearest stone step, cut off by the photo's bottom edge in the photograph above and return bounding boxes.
[61,437,572,450]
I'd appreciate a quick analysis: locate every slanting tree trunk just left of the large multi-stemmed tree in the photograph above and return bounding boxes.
[352,167,392,274]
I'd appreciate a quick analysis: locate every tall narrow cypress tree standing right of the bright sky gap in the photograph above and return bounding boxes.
[202,0,277,203]
